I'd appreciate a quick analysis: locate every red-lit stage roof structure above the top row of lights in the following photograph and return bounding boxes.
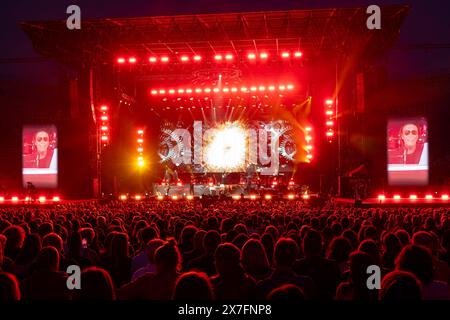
[21,5,409,65]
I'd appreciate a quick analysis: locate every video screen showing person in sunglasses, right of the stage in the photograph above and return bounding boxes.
[387,118,428,186]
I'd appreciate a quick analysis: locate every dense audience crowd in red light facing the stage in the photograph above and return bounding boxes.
[0,201,450,300]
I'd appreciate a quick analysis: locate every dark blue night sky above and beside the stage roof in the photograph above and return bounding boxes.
[0,0,450,81]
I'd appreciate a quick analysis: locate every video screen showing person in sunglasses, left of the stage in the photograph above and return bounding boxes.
[22,125,58,188]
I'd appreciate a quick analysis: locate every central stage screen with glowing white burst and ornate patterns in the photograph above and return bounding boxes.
[158,120,305,175]
